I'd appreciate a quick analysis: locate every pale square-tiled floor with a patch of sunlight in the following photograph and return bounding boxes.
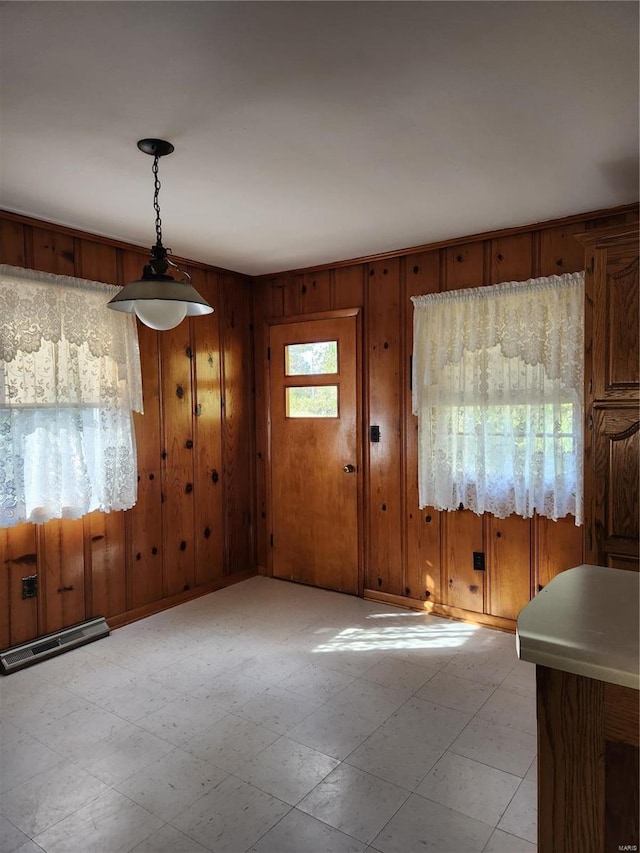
[0,577,536,853]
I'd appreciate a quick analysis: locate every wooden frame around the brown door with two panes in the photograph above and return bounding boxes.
[264,307,366,598]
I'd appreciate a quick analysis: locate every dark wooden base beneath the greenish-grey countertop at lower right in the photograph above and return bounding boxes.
[536,666,640,853]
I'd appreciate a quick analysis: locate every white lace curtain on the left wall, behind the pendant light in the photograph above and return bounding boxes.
[0,265,142,527]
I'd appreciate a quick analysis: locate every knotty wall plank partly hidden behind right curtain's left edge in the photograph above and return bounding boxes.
[403,250,442,602]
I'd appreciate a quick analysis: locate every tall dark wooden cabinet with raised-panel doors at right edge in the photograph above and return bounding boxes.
[576,222,640,571]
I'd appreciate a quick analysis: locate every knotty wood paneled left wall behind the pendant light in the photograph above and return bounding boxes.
[0,213,256,648]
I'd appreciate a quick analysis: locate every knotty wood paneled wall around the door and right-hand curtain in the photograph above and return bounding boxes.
[254,200,637,628]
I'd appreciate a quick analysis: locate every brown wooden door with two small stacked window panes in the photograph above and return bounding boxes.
[269,314,361,594]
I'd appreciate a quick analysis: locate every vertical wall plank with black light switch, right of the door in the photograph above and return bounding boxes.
[365,258,404,595]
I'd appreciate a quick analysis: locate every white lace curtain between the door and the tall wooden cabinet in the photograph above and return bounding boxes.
[412,273,584,525]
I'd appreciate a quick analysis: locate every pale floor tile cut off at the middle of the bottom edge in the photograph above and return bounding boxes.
[249,809,365,853]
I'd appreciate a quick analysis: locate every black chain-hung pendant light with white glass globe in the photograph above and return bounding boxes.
[107,139,213,331]
